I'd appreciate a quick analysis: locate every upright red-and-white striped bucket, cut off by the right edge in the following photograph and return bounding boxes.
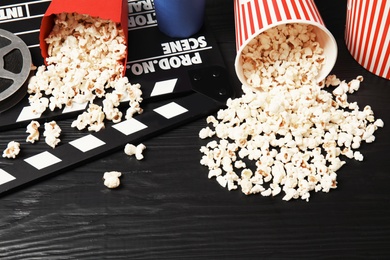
[345,0,390,79]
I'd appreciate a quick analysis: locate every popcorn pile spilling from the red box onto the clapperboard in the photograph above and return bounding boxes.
[28,13,142,131]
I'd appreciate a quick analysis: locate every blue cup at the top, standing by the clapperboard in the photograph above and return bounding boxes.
[154,0,206,38]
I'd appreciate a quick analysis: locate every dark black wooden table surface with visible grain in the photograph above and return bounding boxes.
[0,0,390,260]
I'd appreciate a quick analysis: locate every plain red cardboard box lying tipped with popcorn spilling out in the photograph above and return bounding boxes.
[39,0,128,73]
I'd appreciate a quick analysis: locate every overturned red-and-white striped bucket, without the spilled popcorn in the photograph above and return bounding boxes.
[234,0,337,85]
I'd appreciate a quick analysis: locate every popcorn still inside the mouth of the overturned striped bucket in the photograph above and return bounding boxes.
[241,23,325,91]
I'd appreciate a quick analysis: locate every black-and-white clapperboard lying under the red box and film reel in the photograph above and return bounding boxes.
[0,0,234,194]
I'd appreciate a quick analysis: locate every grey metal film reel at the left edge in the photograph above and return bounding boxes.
[0,29,31,113]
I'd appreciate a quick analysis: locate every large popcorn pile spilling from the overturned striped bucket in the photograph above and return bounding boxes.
[199,24,384,201]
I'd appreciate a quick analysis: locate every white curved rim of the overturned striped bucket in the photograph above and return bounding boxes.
[234,0,338,86]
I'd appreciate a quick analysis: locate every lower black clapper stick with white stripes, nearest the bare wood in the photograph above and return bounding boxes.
[0,93,227,193]
